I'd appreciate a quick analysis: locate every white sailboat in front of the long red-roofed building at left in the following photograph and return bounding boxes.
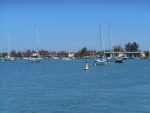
[29,26,43,63]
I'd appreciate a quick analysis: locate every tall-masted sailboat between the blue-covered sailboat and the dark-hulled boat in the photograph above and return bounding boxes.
[107,24,115,62]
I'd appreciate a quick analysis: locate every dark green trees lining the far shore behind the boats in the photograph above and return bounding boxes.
[2,42,149,58]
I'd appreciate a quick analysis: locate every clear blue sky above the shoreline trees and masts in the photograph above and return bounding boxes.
[0,0,150,52]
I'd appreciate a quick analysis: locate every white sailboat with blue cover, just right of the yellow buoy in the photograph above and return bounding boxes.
[95,24,107,65]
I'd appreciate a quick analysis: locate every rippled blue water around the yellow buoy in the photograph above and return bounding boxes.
[0,60,150,113]
